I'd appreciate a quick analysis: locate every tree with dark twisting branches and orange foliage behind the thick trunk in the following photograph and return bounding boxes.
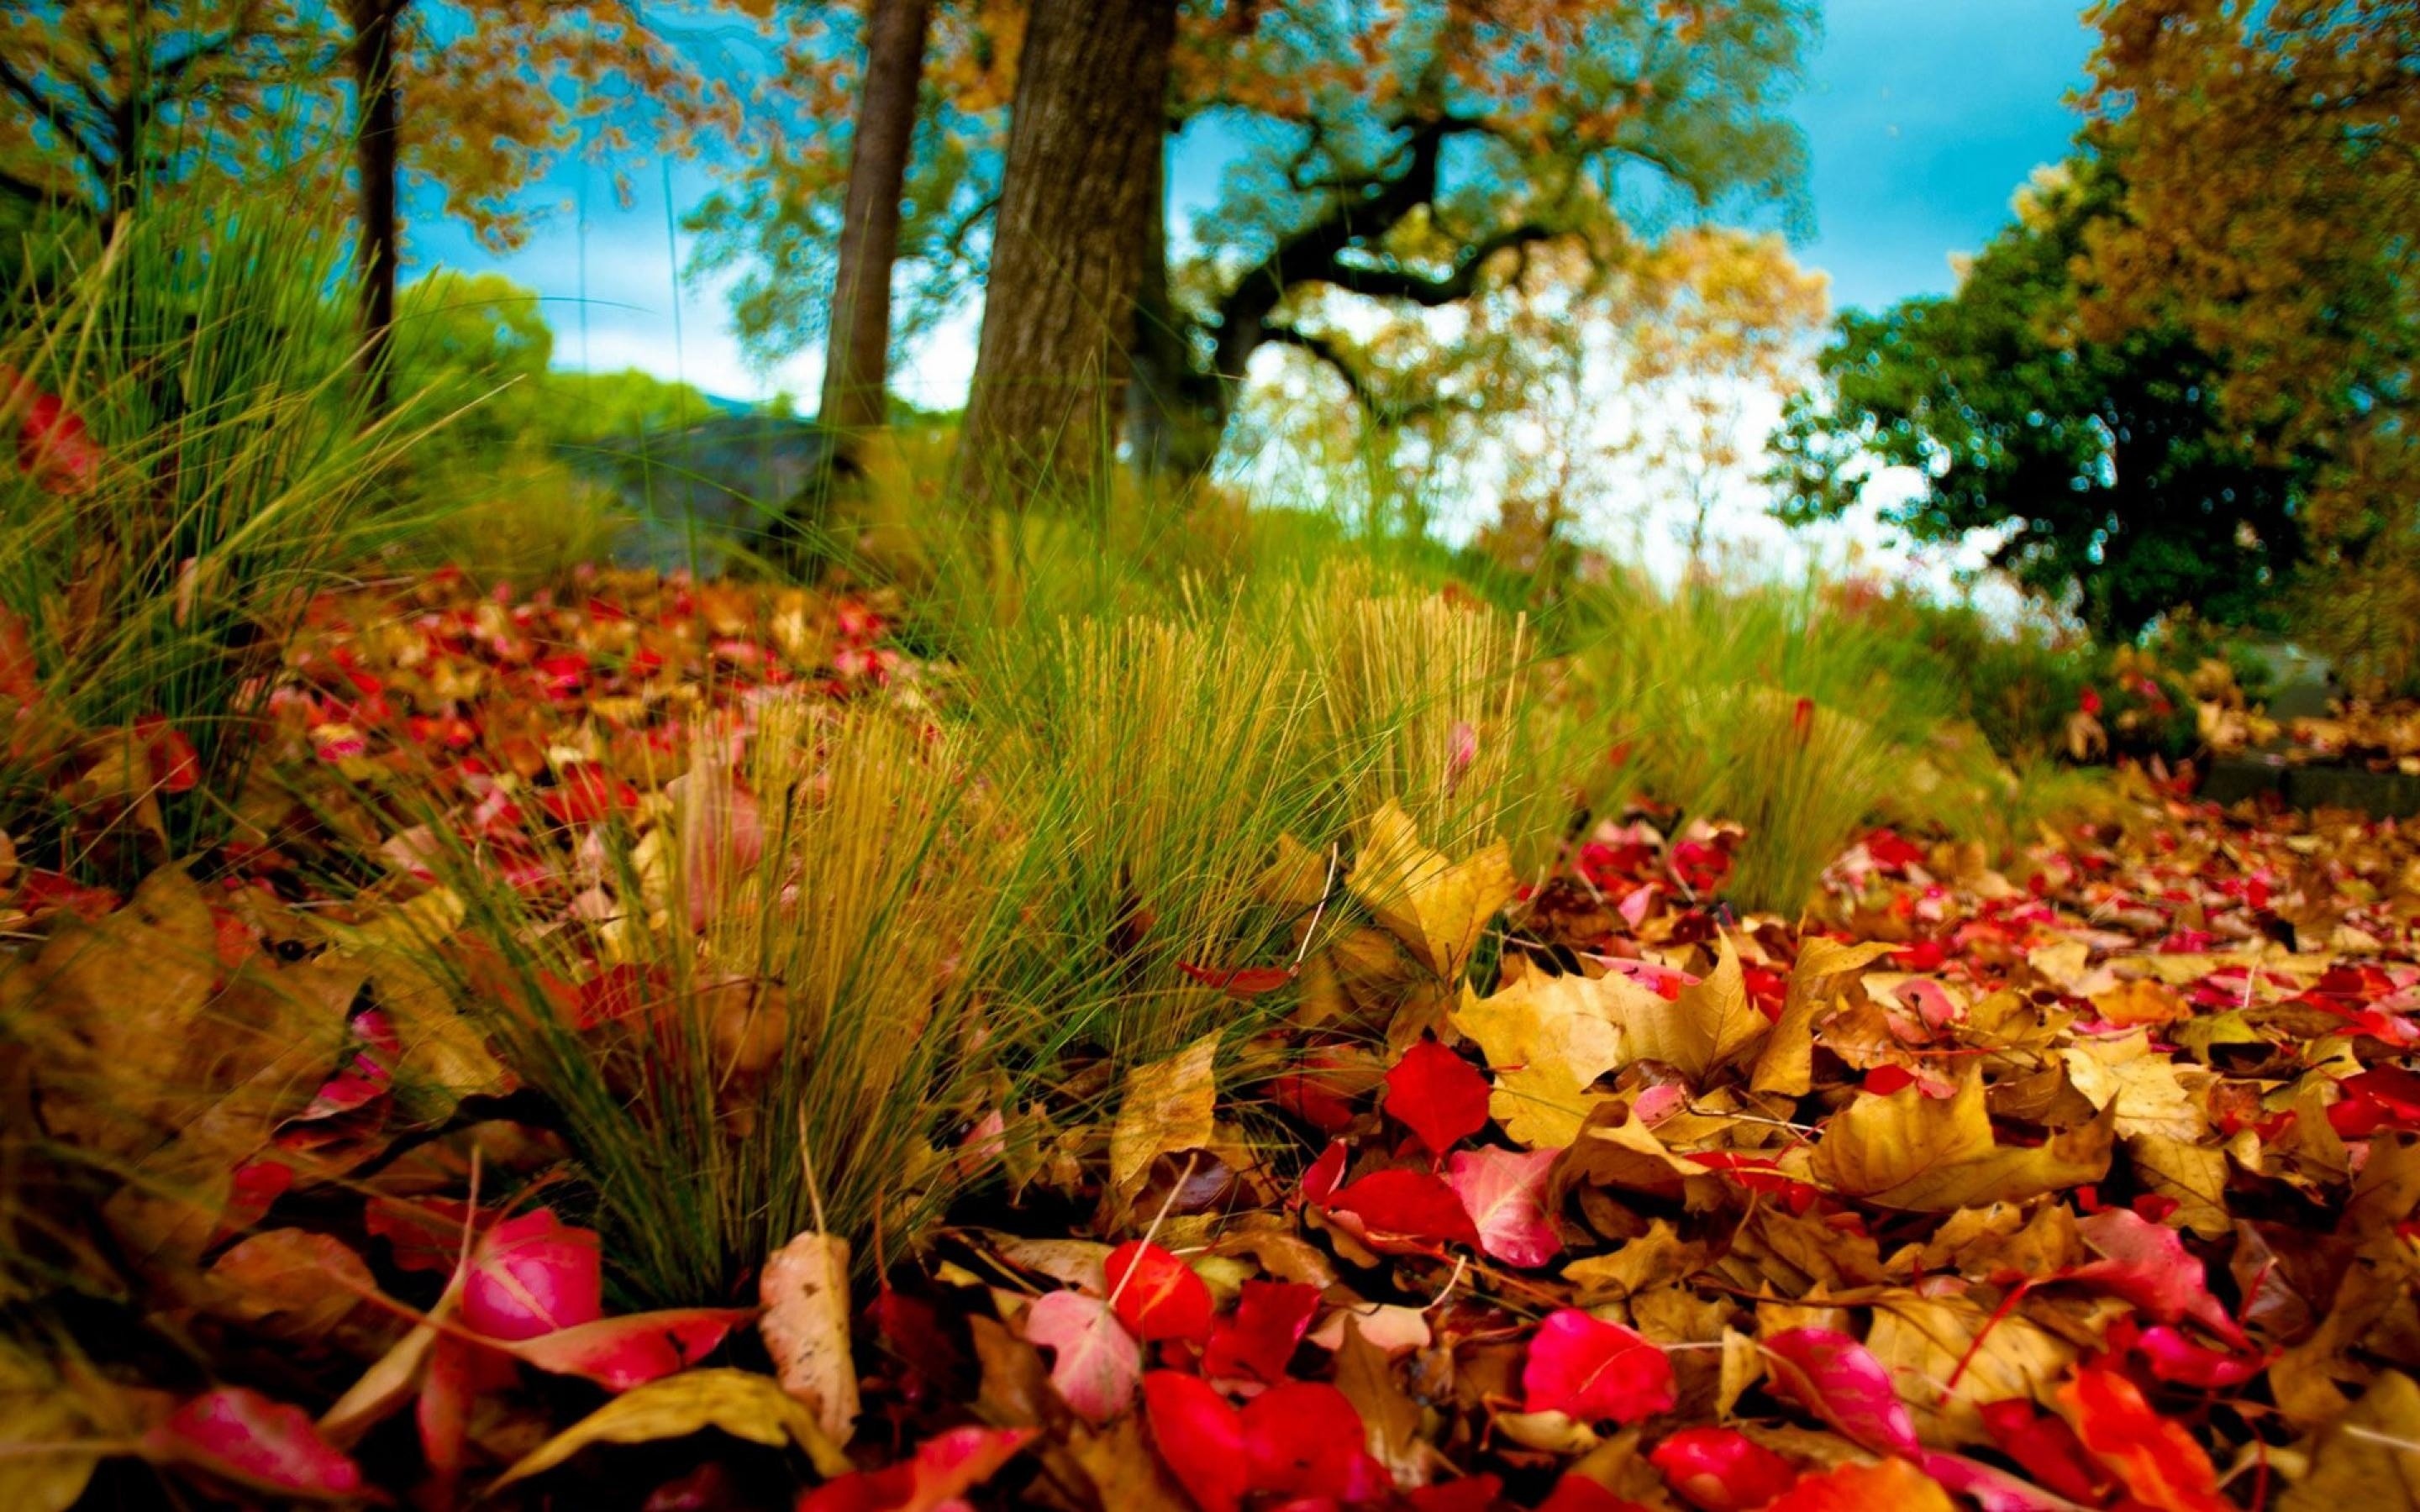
[697,0,1818,474]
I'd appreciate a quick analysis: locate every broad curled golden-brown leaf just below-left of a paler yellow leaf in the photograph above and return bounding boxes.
[1812,1074,2112,1212]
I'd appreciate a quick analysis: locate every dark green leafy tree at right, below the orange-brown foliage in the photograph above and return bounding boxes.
[1771,152,2309,638]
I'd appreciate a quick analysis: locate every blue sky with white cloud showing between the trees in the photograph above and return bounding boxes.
[407,0,2091,404]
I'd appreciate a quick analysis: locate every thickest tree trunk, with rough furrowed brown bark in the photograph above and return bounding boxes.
[958,0,1176,506]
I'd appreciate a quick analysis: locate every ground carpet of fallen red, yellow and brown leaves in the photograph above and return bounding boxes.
[0,575,2420,1512]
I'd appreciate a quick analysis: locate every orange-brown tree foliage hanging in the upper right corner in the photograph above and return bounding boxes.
[2079,0,2420,685]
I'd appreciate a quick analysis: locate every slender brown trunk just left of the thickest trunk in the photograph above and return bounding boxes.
[818,0,929,447]
